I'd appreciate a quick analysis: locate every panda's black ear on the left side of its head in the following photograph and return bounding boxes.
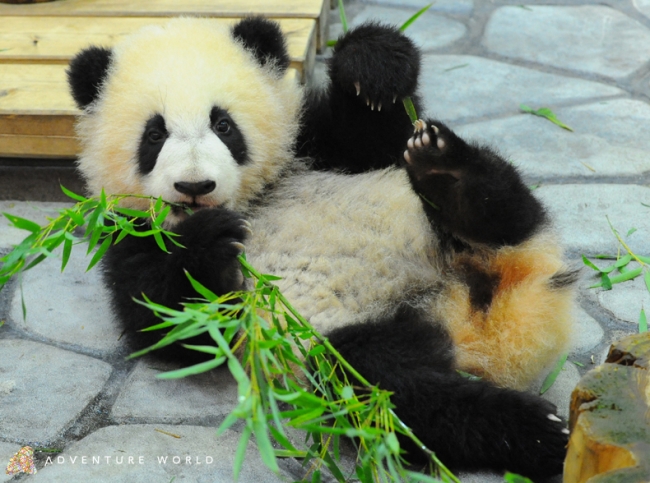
[66,47,112,109]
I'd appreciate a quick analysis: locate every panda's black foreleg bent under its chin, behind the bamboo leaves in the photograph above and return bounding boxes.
[102,209,248,360]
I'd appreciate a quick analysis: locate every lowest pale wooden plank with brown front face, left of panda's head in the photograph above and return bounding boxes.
[0,64,300,158]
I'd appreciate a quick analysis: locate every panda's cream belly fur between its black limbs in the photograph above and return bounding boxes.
[246,169,440,333]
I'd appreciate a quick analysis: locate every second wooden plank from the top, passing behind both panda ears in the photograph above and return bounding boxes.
[0,17,316,72]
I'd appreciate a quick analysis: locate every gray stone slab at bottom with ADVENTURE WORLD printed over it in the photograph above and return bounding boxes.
[30,424,293,483]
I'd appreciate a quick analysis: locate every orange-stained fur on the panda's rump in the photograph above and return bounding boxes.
[439,235,573,389]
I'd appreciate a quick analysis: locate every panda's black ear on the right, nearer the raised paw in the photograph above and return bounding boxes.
[232,17,289,72]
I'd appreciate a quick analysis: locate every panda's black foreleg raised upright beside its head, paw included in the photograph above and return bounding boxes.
[297,23,420,173]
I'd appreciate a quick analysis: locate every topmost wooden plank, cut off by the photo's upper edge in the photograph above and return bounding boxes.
[0,0,329,49]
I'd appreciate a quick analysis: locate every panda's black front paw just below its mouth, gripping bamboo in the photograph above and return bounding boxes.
[173,208,251,295]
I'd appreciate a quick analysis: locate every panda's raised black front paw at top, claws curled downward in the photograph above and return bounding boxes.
[329,23,420,111]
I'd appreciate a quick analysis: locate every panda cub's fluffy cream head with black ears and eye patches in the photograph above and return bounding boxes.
[68,18,301,223]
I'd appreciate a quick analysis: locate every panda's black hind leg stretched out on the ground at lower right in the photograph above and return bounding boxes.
[328,307,568,477]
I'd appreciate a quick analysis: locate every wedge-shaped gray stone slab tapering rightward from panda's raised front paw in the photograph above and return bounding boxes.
[420,54,624,122]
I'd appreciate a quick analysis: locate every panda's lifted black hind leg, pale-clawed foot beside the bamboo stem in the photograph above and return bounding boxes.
[403,119,546,245]
